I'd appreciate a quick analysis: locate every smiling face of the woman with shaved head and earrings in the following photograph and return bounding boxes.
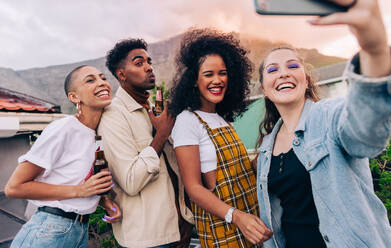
[68,66,111,109]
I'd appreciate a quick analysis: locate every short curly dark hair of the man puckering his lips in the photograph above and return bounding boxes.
[106,39,148,79]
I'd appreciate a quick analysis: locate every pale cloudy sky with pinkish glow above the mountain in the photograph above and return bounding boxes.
[0,0,391,70]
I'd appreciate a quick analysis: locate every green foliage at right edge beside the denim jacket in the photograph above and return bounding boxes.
[370,140,391,223]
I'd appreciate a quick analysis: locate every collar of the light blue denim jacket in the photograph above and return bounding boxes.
[259,99,314,152]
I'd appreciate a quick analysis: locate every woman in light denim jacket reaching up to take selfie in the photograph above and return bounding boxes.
[257,0,391,248]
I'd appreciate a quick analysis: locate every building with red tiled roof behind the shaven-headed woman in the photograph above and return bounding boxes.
[0,87,65,248]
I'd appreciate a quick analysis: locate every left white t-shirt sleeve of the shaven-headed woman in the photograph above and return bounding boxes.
[18,119,66,177]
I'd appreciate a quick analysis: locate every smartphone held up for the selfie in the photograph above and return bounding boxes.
[254,0,348,16]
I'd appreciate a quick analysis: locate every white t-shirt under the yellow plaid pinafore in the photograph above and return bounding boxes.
[171,110,228,173]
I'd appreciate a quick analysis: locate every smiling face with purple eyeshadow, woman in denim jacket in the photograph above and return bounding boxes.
[262,49,308,105]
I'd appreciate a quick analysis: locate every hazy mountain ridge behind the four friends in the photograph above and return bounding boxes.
[0,33,344,113]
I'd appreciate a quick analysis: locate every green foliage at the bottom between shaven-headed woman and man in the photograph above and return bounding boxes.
[88,206,120,248]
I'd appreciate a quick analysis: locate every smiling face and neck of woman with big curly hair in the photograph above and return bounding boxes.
[197,54,228,112]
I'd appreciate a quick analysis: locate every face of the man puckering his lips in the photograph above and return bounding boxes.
[117,48,155,92]
